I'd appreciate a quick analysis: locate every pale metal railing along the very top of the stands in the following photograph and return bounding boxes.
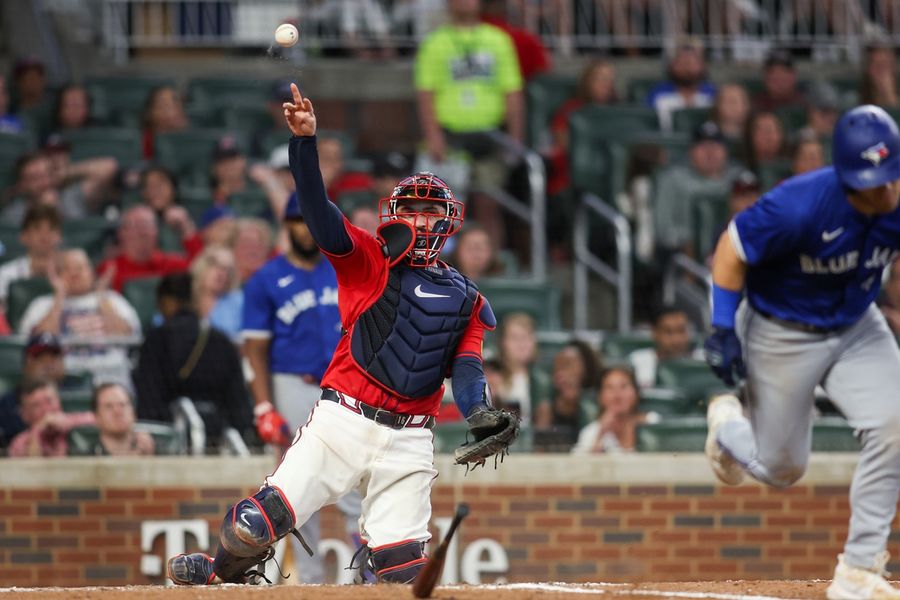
[101,0,900,62]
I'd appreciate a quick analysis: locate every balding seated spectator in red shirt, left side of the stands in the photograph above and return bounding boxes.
[97,205,203,292]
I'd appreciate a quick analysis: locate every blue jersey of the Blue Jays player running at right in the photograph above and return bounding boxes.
[728,167,900,328]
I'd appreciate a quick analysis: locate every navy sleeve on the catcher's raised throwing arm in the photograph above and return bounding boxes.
[289,135,353,256]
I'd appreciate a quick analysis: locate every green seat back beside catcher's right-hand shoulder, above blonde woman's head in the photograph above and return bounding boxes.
[478,278,560,330]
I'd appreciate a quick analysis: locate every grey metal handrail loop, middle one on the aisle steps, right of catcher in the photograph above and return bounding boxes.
[572,194,632,332]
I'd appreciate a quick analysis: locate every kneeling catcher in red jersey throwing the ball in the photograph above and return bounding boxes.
[168,84,518,585]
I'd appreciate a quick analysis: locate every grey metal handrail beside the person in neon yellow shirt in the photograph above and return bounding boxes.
[472,131,547,281]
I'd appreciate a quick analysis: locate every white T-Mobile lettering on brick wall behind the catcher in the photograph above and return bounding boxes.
[141,517,509,585]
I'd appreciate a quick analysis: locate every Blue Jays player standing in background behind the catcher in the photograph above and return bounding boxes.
[242,194,361,583]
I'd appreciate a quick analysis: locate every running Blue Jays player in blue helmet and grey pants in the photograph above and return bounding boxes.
[705,105,900,599]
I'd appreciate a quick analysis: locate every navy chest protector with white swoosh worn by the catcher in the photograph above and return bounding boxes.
[350,265,478,398]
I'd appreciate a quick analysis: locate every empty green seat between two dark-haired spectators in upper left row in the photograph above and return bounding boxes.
[85,75,175,124]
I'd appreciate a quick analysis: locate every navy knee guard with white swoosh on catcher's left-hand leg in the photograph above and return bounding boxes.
[219,486,294,557]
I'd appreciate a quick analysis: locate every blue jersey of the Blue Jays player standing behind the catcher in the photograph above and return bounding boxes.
[242,256,341,379]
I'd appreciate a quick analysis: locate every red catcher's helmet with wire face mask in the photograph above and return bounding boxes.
[378,171,465,267]
